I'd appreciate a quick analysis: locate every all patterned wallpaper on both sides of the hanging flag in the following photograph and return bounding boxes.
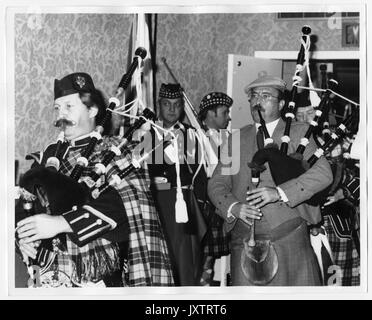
[15,13,353,172]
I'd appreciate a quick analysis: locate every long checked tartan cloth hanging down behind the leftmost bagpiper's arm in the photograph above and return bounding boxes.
[99,142,174,286]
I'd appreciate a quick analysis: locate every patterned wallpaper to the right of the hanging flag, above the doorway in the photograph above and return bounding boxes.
[157,13,355,107]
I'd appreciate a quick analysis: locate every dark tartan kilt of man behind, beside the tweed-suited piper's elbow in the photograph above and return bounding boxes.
[203,201,231,259]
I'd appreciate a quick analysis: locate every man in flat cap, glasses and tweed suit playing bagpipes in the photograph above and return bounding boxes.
[208,76,332,286]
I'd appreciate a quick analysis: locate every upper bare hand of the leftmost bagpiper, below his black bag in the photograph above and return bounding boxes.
[17,213,72,243]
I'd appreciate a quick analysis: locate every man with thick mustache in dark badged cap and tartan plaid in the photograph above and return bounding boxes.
[17,72,173,287]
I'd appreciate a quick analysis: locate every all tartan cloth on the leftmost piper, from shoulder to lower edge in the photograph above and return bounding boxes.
[55,137,174,286]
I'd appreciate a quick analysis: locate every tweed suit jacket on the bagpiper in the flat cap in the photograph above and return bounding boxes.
[208,119,333,230]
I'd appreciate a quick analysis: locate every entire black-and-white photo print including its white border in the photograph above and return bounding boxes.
[3,2,368,299]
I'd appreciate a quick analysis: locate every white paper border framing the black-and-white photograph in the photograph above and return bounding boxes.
[0,1,371,300]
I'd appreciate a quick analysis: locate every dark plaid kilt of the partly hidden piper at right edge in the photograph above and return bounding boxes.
[323,215,360,286]
